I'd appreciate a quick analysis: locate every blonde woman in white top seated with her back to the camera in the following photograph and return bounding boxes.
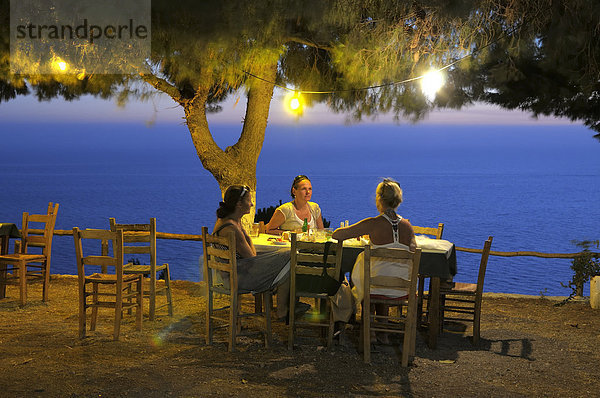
[333,178,417,341]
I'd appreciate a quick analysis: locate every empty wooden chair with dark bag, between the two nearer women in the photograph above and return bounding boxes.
[288,233,343,350]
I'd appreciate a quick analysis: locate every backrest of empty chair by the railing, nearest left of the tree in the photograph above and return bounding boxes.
[109,217,156,265]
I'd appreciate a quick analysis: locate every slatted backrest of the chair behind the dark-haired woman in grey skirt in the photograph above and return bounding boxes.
[202,227,238,291]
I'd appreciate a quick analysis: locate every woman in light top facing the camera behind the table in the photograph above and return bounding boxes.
[265,175,323,235]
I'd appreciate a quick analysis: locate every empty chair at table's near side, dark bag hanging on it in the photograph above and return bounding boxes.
[288,233,343,350]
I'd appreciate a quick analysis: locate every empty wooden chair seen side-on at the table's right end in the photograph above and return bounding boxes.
[440,236,493,345]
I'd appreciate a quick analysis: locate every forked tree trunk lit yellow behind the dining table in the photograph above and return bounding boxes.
[183,62,277,228]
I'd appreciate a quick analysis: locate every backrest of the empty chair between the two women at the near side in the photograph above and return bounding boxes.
[290,233,343,282]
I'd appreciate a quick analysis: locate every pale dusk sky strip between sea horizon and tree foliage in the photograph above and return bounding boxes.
[0,86,577,126]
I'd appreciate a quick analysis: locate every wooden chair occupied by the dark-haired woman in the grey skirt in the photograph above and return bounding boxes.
[202,227,273,351]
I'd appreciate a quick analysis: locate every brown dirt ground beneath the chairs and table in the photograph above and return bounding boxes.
[0,275,600,397]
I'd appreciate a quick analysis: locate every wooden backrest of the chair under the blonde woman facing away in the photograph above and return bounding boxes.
[363,246,421,297]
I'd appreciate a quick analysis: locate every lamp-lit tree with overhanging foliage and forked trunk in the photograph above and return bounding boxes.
[0,0,600,205]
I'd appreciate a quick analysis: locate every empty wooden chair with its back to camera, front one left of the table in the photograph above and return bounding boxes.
[73,227,142,340]
